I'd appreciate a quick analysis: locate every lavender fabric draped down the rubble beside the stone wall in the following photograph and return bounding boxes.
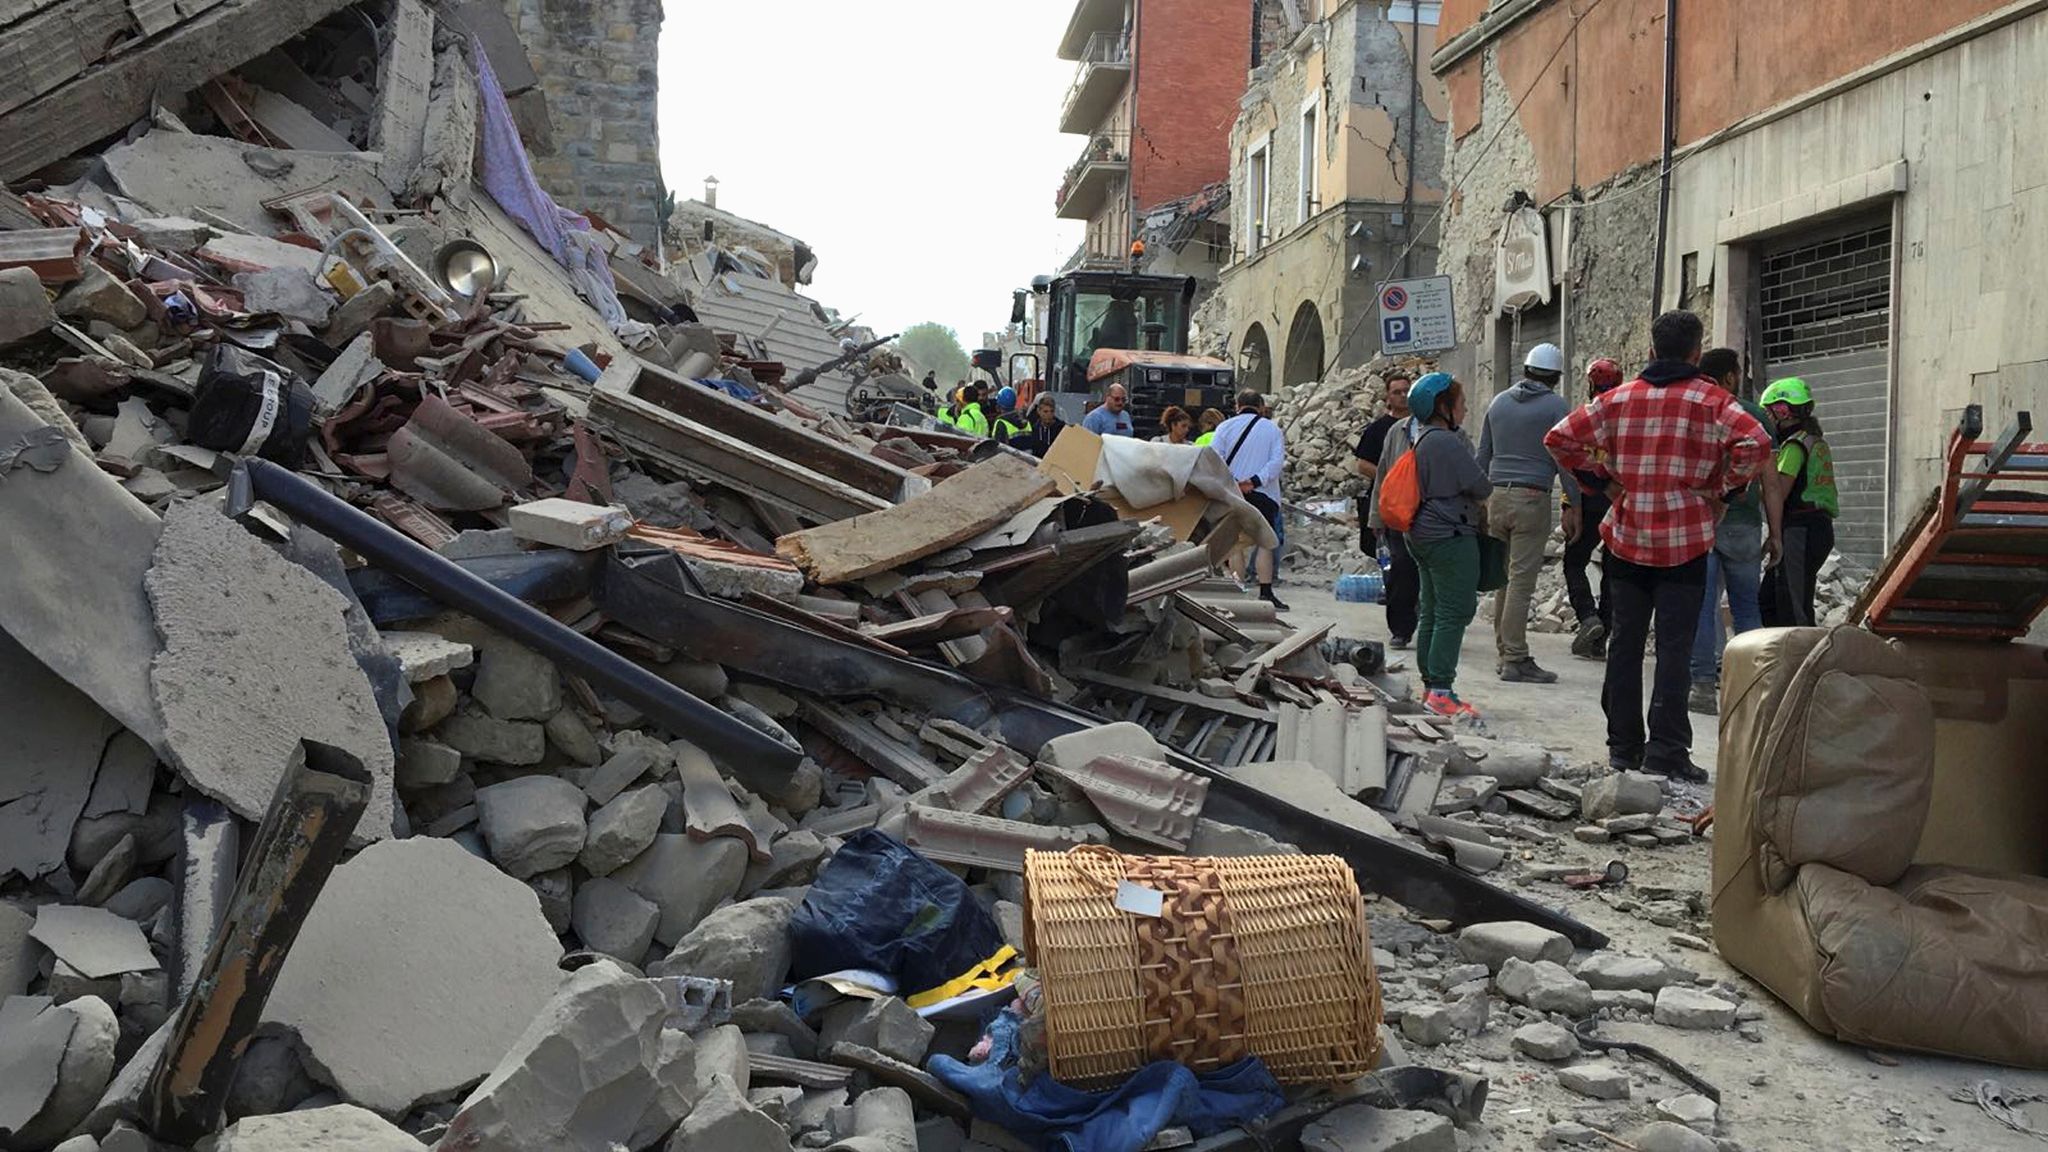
[471,39,653,348]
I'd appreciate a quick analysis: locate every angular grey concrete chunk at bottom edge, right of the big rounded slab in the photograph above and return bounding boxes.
[440,961,668,1152]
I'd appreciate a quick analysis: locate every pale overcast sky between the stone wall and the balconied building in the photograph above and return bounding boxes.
[662,0,1085,351]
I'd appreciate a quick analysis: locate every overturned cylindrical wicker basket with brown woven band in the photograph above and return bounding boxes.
[1024,845,1380,1088]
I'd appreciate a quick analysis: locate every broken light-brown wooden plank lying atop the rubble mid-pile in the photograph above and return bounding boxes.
[774,455,1055,584]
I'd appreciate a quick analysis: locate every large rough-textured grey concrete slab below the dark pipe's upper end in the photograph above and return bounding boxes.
[143,500,395,842]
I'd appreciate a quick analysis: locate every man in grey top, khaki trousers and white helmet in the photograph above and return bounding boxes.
[1479,344,1579,685]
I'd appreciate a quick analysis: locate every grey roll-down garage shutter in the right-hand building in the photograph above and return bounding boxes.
[1757,217,1892,568]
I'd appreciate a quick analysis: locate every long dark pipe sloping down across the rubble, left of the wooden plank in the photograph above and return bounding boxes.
[227,459,803,773]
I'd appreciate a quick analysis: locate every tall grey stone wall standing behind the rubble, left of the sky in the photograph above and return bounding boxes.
[504,0,662,244]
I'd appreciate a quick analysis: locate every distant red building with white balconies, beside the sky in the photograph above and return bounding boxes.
[1053,0,1253,270]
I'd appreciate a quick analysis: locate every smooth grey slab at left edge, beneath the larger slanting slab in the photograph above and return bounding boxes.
[0,619,121,879]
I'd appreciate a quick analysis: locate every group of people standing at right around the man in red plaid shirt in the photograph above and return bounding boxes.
[1354,312,1839,781]
